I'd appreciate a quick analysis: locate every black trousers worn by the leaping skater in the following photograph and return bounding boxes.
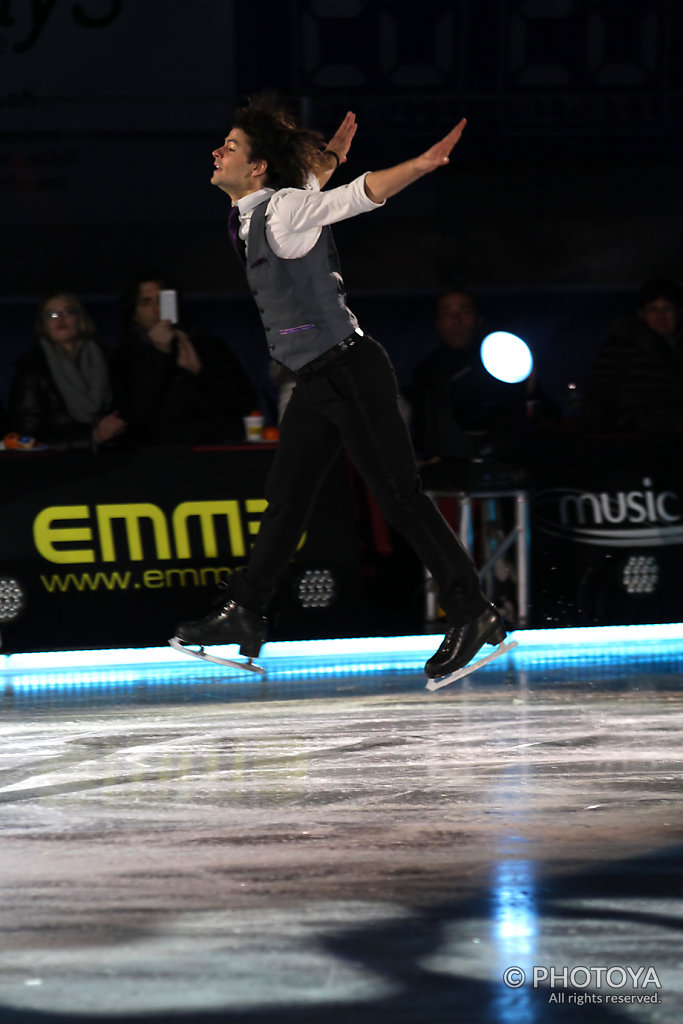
[233,335,488,625]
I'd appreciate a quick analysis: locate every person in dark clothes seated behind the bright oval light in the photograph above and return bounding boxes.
[411,288,527,460]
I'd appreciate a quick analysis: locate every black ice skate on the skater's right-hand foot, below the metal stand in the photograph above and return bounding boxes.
[425,604,518,690]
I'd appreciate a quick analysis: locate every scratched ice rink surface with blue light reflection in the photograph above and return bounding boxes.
[0,626,683,1024]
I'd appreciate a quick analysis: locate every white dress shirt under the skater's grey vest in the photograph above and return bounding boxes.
[238,174,384,259]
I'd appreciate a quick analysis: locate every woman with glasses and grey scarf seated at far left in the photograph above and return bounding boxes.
[9,291,126,449]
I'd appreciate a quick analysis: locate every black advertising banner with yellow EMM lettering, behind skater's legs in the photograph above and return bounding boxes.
[0,445,374,651]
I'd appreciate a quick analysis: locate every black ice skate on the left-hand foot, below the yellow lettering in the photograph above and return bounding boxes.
[169,597,268,675]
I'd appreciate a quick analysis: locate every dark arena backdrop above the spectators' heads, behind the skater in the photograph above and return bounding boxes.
[0,0,683,411]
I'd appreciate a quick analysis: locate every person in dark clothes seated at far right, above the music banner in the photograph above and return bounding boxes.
[583,278,683,435]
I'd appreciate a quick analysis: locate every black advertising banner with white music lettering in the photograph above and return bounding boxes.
[530,436,683,626]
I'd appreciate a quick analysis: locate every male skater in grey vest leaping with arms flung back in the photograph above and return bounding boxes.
[176,96,505,678]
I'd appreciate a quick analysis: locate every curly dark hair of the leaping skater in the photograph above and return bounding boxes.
[232,92,325,188]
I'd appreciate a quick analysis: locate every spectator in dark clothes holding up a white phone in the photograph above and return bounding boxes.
[113,273,257,444]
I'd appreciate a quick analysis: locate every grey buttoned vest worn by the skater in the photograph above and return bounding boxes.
[247,197,358,371]
